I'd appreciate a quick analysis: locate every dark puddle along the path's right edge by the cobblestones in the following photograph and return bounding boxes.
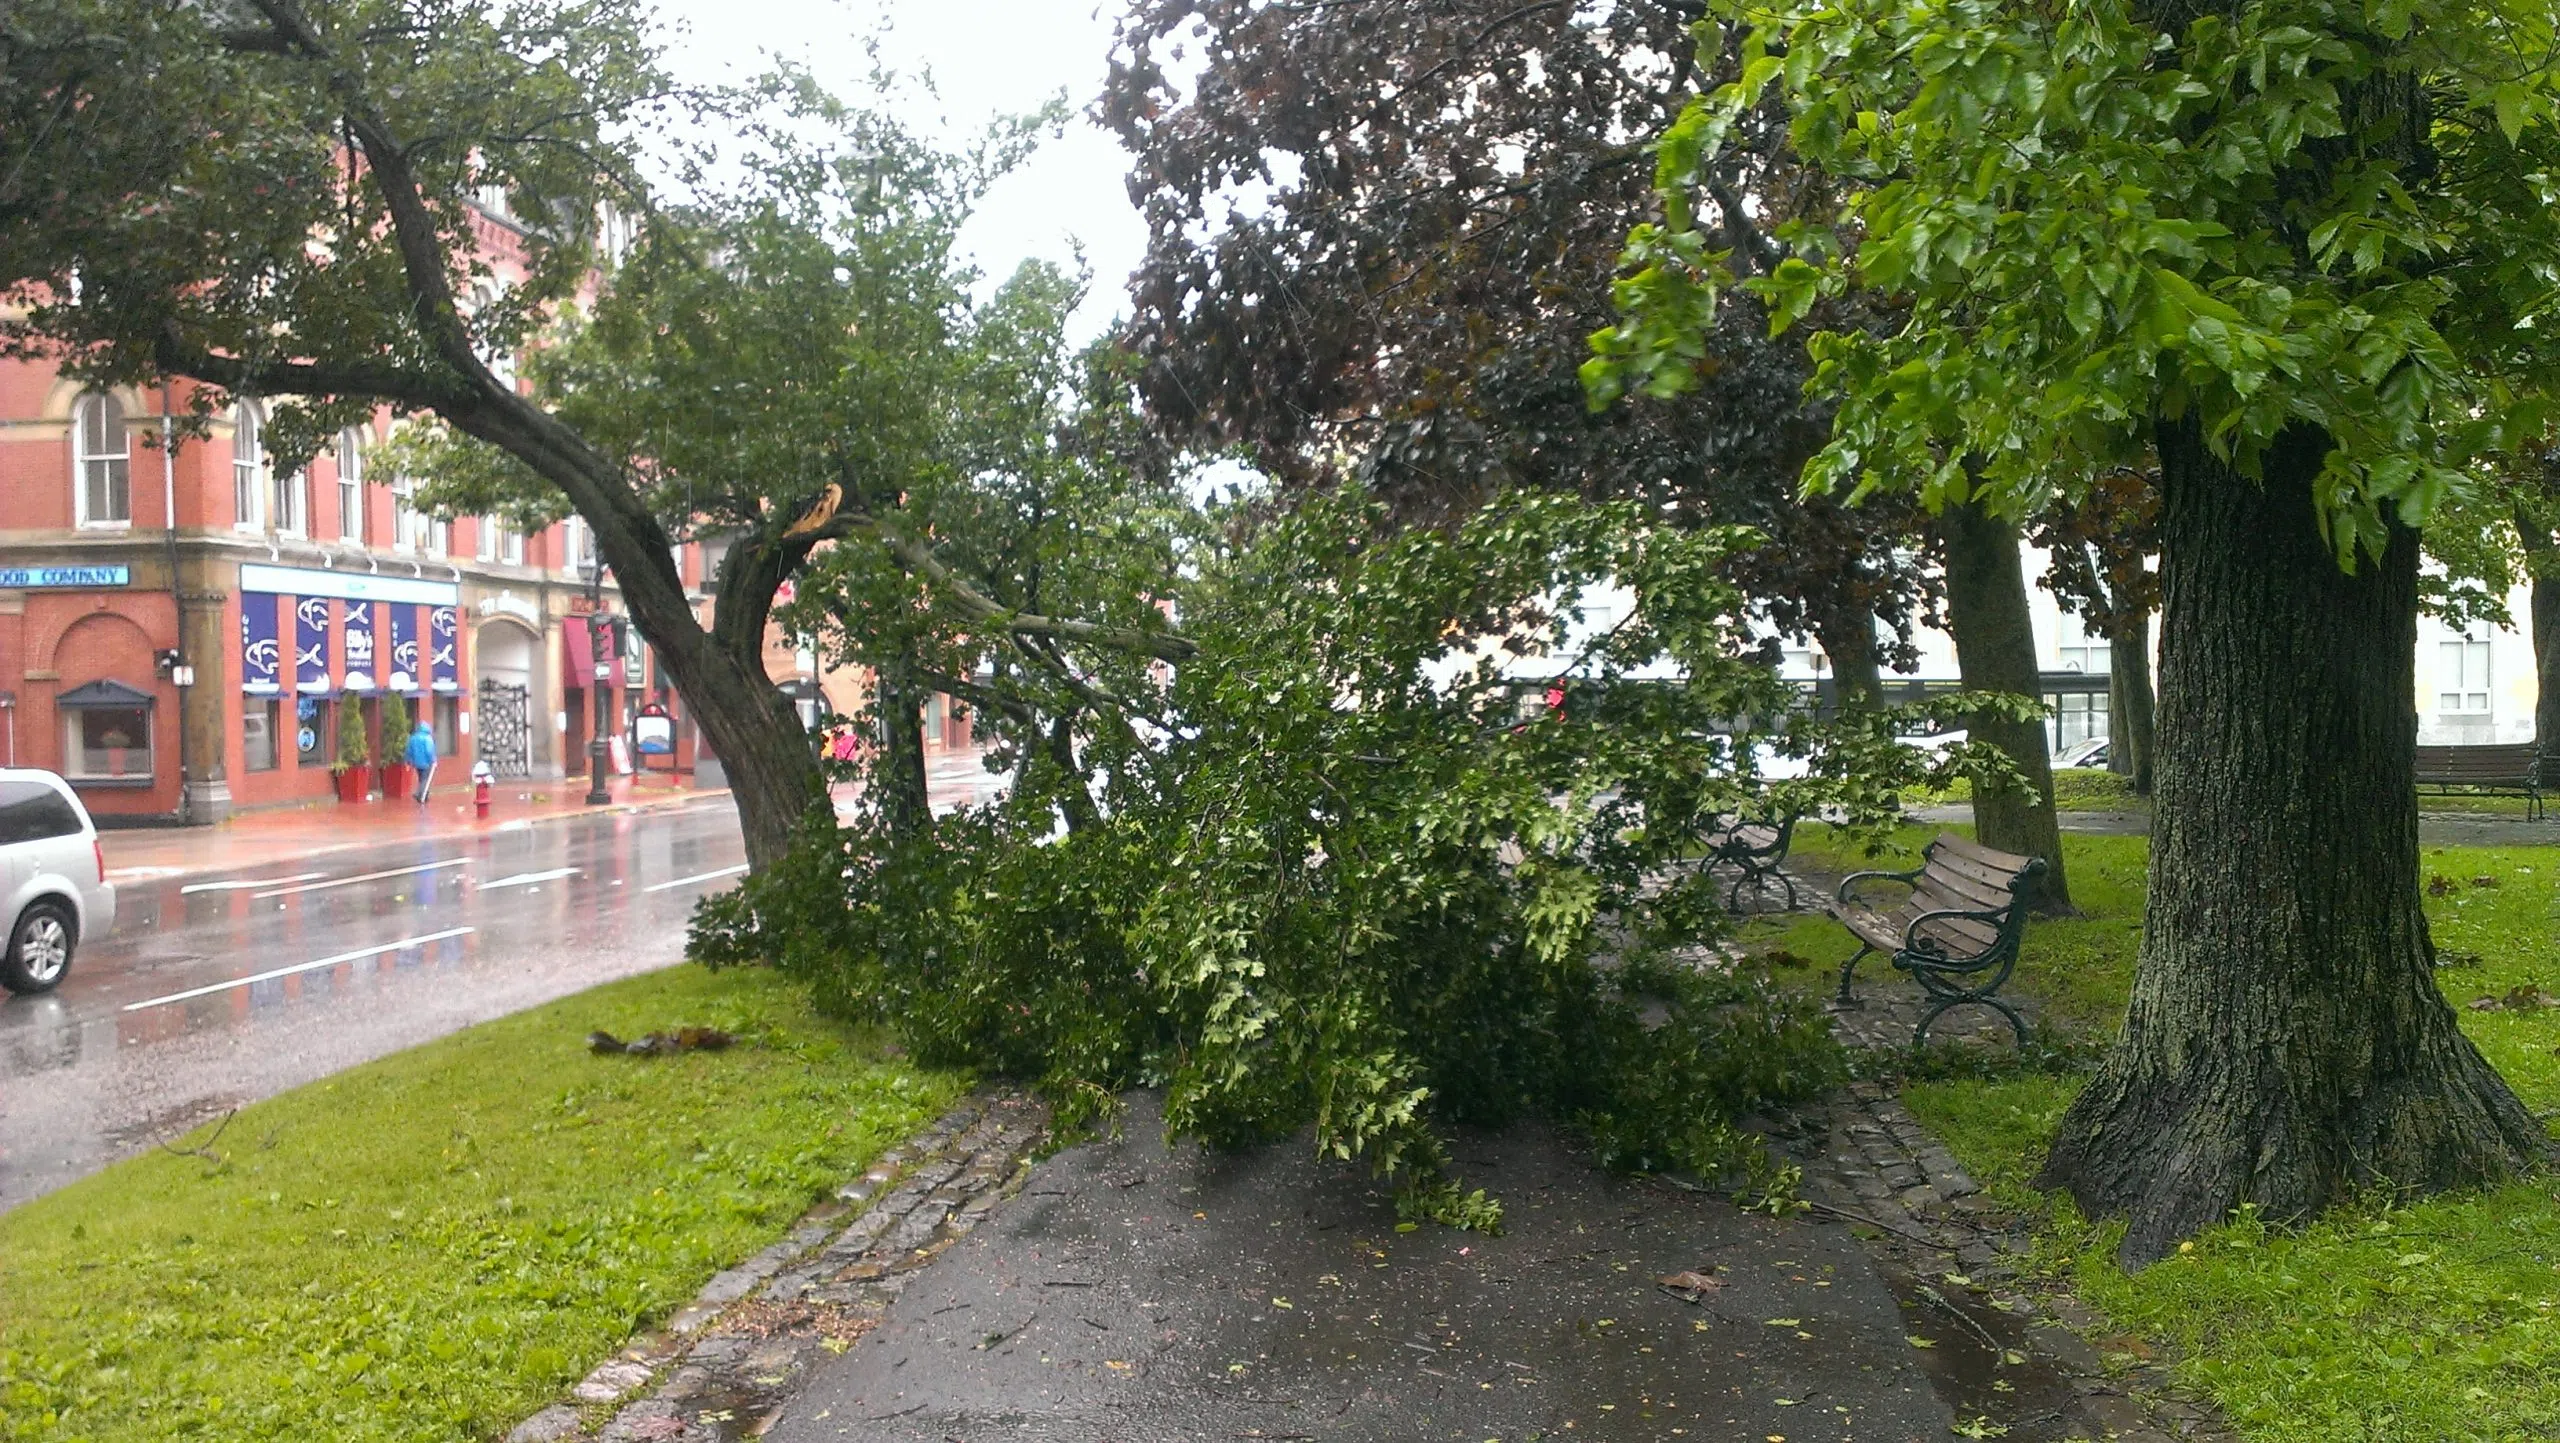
[1876,1259,2104,1443]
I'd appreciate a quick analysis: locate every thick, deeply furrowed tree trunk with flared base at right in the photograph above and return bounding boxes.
[2043,420,2545,1266]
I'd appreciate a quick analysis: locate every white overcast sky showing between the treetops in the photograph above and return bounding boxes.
[660,0,1147,340]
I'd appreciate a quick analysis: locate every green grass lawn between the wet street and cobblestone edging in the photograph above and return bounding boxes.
[0,967,963,1443]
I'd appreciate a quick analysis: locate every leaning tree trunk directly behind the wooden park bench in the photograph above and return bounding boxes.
[1938,501,2071,911]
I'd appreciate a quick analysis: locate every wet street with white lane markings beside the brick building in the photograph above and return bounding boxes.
[0,798,745,1210]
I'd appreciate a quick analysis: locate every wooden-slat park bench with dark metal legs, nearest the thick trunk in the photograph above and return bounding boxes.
[1833,832,2045,1046]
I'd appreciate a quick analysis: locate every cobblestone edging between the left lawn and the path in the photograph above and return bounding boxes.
[507,1092,1050,1443]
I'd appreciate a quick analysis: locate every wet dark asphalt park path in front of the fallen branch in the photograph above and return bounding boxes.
[765,1095,1953,1443]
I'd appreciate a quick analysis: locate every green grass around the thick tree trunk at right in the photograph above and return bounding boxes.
[1754,829,2560,1443]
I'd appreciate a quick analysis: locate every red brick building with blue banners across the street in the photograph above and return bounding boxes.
[0,363,732,821]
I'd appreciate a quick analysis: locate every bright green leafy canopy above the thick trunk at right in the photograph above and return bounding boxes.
[1585,0,2560,565]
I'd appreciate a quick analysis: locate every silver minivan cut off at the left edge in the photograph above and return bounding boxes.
[0,768,115,993]
